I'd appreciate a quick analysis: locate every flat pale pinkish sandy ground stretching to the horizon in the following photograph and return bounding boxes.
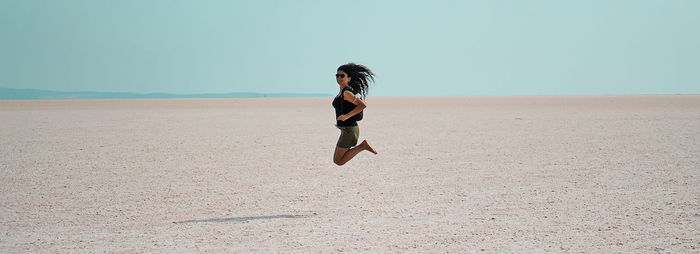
[0,95,700,253]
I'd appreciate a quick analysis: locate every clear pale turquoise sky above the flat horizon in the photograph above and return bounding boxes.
[0,0,700,96]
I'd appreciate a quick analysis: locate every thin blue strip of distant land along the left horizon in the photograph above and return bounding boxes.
[0,88,332,100]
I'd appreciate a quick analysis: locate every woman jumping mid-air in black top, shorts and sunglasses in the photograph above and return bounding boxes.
[333,63,377,166]
